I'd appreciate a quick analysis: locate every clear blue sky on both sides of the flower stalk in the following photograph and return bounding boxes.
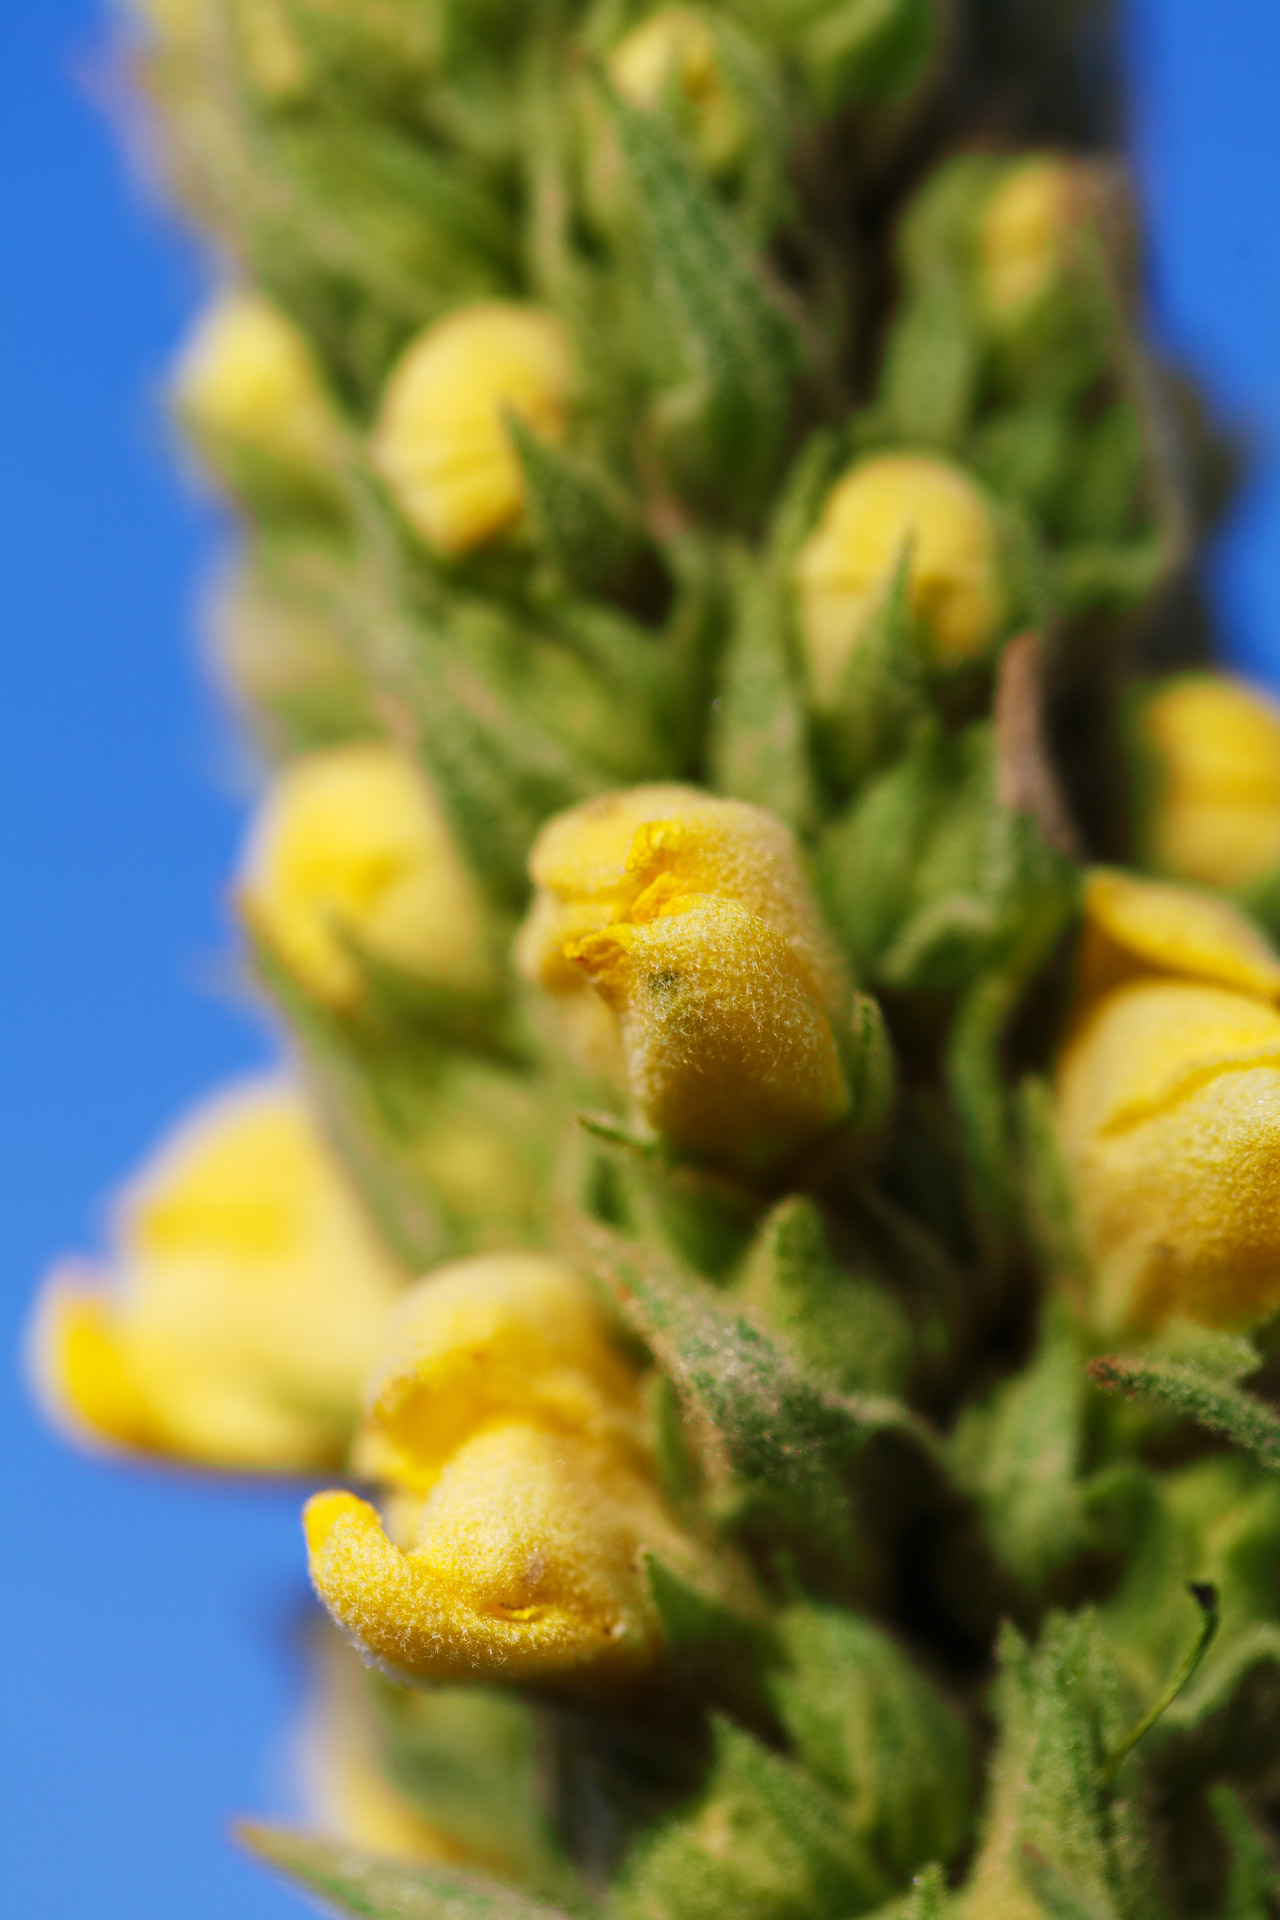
[0,0,1280,1920]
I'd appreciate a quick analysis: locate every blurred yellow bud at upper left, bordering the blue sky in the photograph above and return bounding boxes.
[173,292,342,478]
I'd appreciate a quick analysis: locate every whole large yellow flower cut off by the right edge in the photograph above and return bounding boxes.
[1057,874,1280,1334]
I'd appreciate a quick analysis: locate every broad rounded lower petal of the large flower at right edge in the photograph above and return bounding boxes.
[1057,979,1280,1332]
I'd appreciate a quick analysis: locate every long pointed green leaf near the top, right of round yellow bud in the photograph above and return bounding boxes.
[604,88,800,507]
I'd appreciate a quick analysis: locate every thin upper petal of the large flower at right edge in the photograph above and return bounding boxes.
[1080,868,1280,1000]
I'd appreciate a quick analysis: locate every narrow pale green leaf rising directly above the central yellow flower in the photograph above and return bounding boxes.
[708,553,818,833]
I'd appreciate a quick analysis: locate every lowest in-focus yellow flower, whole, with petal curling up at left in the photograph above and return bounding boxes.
[305,1256,717,1680]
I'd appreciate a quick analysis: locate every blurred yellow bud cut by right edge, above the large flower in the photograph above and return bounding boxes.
[1140,674,1280,887]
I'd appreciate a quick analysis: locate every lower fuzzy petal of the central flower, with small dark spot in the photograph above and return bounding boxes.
[570,895,850,1171]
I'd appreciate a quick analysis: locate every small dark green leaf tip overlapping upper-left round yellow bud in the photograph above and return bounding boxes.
[507,413,645,593]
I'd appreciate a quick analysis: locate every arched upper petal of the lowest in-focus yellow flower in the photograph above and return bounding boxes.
[361,1254,639,1492]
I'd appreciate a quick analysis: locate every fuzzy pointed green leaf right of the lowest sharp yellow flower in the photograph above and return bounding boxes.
[578,1219,938,1546]
